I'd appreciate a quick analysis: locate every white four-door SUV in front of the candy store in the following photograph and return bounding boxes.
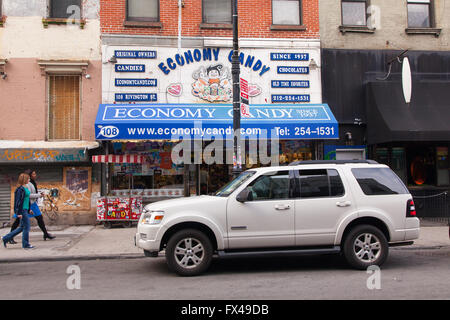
[135,160,419,276]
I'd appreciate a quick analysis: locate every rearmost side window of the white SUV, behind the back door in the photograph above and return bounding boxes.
[352,168,409,196]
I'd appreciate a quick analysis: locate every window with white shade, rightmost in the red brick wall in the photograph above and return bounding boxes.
[272,0,302,25]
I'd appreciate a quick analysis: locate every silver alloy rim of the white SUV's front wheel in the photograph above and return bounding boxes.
[175,238,205,269]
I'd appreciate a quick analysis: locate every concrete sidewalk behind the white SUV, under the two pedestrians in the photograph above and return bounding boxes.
[0,222,450,263]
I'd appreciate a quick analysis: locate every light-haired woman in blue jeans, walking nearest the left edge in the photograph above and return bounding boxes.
[2,173,35,249]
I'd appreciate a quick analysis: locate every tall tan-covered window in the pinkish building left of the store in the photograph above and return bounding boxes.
[48,75,80,140]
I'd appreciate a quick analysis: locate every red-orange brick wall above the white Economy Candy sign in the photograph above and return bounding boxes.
[100,0,319,39]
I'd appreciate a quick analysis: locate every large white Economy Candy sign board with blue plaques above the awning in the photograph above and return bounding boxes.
[102,42,322,105]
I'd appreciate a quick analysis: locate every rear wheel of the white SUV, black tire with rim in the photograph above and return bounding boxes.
[343,225,389,270]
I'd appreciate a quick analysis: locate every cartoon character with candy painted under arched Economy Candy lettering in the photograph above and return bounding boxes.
[192,64,233,102]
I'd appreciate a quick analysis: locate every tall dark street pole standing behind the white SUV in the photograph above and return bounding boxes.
[231,0,242,177]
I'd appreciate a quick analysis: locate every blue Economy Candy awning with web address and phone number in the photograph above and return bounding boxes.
[95,104,339,140]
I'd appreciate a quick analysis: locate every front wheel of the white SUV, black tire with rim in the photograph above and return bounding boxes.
[166,229,213,276]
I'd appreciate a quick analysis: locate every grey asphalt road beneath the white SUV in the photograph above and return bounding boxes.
[0,247,450,300]
